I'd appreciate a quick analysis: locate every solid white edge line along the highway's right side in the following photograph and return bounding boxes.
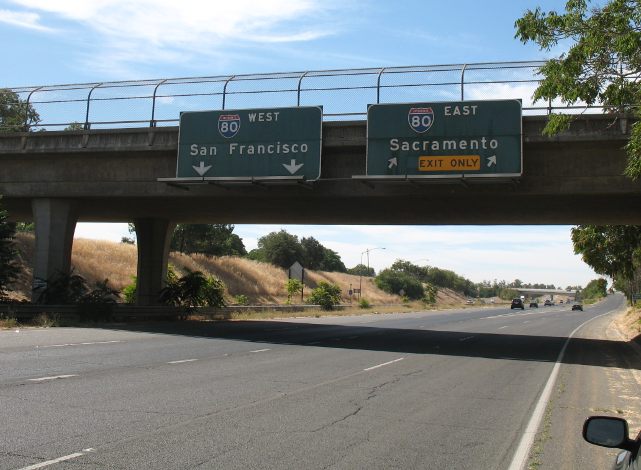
[508,311,612,470]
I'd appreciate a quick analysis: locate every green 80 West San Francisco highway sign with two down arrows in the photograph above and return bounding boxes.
[176,106,323,181]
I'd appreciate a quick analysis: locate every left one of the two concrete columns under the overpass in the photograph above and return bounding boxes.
[31,199,78,300]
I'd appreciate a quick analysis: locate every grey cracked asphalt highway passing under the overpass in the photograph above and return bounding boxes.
[0,295,624,470]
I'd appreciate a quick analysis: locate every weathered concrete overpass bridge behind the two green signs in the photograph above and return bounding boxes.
[0,63,641,304]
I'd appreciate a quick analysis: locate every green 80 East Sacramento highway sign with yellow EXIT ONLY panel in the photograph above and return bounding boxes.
[367,100,523,178]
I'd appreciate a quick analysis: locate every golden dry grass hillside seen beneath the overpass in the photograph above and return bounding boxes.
[7,233,465,306]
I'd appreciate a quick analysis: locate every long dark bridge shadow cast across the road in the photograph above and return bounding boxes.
[97,321,641,370]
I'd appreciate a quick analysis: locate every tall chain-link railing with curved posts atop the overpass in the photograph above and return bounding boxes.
[0,61,604,130]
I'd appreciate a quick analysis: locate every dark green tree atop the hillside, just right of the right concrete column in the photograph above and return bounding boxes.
[170,224,247,256]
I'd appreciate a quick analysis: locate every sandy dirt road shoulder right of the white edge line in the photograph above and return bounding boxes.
[528,302,641,469]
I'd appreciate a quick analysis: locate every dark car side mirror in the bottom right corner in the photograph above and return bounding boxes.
[583,416,641,470]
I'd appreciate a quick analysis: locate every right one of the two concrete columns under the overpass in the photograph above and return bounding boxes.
[134,219,175,305]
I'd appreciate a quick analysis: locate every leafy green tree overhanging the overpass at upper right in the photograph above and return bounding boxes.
[515,0,641,180]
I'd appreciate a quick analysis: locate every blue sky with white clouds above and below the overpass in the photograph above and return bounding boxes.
[0,0,598,287]
